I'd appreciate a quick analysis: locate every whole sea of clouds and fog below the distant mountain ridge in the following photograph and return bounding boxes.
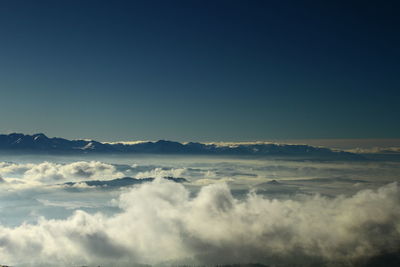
[0,155,400,266]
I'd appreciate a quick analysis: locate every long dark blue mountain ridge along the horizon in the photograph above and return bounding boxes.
[0,133,360,159]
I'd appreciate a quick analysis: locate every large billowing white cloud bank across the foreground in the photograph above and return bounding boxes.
[0,179,400,266]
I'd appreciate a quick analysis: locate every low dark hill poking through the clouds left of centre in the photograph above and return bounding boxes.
[64,176,188,187]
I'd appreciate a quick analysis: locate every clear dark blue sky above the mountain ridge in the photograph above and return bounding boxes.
[0,0,400,141]
